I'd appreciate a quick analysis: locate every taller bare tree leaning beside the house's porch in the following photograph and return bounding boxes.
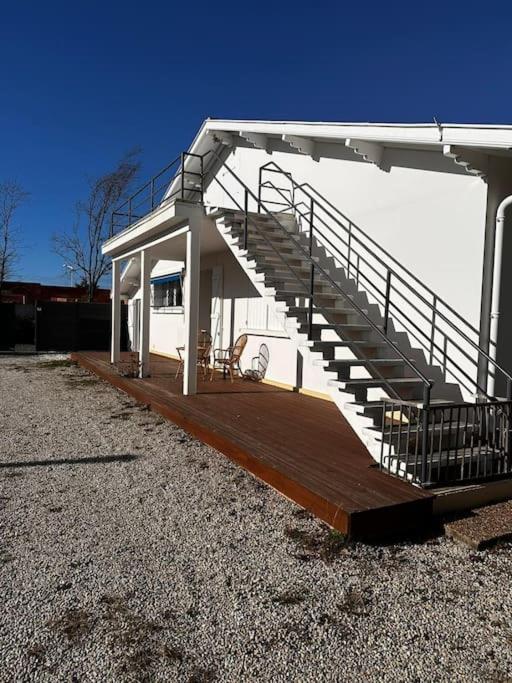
[52,150,140,301]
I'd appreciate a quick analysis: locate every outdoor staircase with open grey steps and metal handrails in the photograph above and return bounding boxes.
[112,151,512,486]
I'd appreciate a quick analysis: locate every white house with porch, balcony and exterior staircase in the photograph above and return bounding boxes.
[103,119,512,492]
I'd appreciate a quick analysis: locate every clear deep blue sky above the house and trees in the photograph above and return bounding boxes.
[0,0,512,283]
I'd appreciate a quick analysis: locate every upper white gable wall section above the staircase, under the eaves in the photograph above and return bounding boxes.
[205,144,487,325]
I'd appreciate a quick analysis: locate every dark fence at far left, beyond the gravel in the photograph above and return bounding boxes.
[0,301,128,352]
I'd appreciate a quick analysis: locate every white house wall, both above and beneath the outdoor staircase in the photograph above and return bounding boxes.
[126,145,487,400]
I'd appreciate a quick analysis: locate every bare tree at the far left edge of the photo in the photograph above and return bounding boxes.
[0,180,29,293]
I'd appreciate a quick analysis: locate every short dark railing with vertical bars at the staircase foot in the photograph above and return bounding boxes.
[380,399,512,487]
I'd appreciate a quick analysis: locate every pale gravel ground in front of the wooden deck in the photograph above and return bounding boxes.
[0,357,512,683]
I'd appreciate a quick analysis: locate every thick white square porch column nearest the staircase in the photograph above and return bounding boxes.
[183,221,201,396]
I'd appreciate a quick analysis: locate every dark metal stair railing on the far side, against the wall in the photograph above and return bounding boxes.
[258,162,512,399]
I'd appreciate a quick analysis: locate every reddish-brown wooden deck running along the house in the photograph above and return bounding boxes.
[72,352,433,539]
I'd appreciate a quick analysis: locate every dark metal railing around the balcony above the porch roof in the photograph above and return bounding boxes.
[109,152,204,237]
